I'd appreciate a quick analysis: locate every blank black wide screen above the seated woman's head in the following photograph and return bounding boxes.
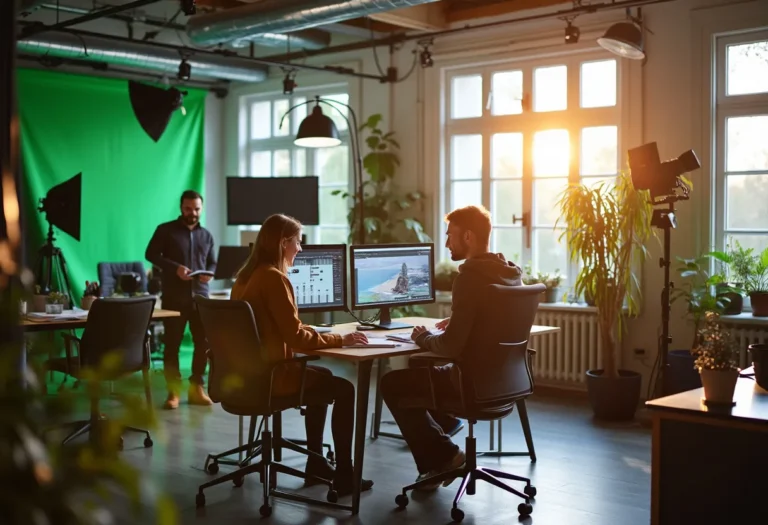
[227,177,320,226]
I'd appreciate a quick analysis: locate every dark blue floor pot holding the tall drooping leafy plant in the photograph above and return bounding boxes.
[587,370,642,421]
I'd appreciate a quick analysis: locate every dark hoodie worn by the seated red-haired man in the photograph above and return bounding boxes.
[416,253,523,358]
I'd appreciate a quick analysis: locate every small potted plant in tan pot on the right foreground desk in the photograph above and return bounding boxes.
[691,312,739,405]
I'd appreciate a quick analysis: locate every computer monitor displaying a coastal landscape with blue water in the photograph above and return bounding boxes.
[350,243,435,330]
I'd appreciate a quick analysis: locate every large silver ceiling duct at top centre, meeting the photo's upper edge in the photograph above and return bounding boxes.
[187,0,437,46]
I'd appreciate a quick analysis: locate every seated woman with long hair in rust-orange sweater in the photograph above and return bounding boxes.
[230,214,373,496]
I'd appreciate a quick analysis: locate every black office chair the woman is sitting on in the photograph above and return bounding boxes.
[195,296,344,517]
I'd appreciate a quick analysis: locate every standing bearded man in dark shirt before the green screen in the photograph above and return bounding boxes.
[146,190,216,409]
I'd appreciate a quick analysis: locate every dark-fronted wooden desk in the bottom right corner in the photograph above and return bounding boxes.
[646,379,768,525]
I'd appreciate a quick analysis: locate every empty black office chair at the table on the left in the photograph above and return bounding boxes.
[47,297,155,449]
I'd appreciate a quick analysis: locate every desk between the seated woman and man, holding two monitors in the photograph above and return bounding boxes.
[301,317,560,514]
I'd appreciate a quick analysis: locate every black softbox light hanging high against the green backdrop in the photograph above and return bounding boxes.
[128,80,187,142]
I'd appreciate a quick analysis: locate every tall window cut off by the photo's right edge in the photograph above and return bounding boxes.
[713,31,768,253]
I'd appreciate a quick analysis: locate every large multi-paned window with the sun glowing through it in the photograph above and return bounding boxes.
[442,51,622,283]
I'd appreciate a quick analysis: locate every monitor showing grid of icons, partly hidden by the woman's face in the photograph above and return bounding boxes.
[288,244,347,313]
